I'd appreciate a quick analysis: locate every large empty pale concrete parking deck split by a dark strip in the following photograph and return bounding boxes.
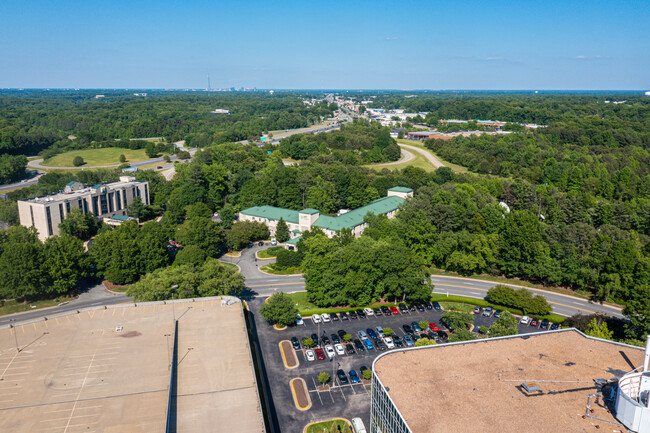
[0,298,264,433]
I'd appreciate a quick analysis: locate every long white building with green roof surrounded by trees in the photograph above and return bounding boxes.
[239,186,413,245]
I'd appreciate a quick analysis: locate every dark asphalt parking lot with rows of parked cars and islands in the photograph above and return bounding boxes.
[250,299,552,431]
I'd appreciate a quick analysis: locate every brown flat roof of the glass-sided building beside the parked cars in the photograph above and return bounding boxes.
[373,329,644,433]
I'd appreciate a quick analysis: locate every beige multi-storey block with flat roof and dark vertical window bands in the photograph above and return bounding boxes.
[18,176,149,241]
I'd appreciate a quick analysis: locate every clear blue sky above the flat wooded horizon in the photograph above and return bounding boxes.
[0,0,650,90]
